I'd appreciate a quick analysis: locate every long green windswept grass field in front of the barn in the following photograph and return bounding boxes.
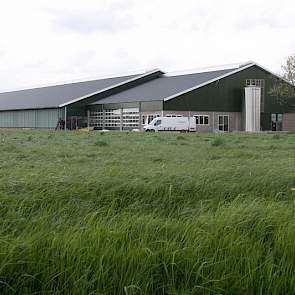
[0,130,295,295]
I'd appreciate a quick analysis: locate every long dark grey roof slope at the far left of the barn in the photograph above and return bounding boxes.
[0,75,138,110]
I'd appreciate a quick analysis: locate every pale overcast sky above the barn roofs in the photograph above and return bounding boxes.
[0,0,295,90]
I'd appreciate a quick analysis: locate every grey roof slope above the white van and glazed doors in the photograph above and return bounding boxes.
[92,68,236,104]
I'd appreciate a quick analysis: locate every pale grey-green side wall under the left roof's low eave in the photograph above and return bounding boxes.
[0,109,64,128]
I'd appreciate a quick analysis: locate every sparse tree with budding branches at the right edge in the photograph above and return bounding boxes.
[270,53,295,103]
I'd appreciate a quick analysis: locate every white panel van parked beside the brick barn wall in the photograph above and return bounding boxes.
[143,117,196,132]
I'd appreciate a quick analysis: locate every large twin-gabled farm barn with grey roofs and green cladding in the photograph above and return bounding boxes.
[0,62,295,131]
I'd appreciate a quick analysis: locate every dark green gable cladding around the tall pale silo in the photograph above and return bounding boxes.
[164,66,295,113]
